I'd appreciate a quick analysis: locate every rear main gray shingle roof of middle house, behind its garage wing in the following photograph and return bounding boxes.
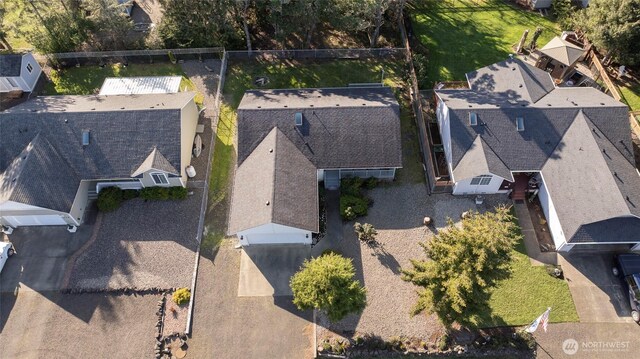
[238,87,402,169]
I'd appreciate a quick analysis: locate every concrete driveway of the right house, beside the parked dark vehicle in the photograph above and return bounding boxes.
[559,253,633,323]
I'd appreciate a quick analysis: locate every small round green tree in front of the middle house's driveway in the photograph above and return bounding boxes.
[290,252,367,321]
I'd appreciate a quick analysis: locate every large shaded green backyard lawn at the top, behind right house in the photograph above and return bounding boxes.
[409,0,560,83]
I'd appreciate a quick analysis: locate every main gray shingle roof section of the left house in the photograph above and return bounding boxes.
[0,93,193,212]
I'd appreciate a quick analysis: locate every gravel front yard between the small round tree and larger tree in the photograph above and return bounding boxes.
[318,184,506,342]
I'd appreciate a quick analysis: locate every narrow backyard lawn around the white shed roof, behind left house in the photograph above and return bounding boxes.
[44,63,203,105]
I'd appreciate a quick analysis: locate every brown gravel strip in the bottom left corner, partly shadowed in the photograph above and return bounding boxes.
[0,291,160,359]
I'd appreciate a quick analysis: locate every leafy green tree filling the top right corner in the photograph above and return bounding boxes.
[575,0,640,65]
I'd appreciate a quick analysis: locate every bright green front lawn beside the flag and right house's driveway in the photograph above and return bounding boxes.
[475,218,579,327]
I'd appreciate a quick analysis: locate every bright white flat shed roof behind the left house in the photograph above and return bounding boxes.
[100,76,182,95]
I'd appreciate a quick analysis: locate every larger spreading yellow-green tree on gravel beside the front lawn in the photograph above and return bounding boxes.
[402,206,519,326]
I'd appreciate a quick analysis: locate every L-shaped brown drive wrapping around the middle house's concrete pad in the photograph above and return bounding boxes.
[188,244,313,359]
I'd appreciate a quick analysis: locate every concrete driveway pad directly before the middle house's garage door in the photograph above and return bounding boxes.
[238,245,311,297]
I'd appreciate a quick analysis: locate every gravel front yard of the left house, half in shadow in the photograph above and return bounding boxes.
[69,189,203,290]
